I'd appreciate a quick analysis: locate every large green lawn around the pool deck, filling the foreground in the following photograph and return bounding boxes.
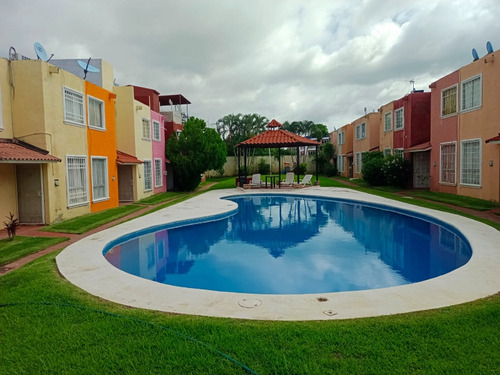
[0,176,500,374]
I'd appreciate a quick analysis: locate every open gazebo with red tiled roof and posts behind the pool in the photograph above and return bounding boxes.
[235,119,321,187]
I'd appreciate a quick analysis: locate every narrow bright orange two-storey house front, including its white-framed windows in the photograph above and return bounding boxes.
[85,81,118,212]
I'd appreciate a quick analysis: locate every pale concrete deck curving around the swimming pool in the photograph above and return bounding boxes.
[56,187,500,320]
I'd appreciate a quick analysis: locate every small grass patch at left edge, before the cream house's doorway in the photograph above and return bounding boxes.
[0,236,69,266]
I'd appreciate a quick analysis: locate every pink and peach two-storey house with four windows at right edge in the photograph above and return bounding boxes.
[429,50,500,202]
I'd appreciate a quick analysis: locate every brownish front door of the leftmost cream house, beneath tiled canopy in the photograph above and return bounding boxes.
[16,164,45,224]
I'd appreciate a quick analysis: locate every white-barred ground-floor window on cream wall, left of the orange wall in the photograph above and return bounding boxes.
[66,155,88,207]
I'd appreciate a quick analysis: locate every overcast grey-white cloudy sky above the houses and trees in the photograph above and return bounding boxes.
[0,0,500,130]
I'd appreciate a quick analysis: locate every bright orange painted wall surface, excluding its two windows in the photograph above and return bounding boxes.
[85,82,118,212]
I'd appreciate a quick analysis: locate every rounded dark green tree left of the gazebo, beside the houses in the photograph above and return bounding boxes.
[165,117,226,191]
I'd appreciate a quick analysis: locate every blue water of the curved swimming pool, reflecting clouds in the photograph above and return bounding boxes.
[104,195,472,294]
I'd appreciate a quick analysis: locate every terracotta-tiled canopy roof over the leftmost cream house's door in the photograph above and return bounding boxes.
[0,138,61,164]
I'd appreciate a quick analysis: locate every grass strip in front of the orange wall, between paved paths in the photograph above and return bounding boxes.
[41,204,143,234]
